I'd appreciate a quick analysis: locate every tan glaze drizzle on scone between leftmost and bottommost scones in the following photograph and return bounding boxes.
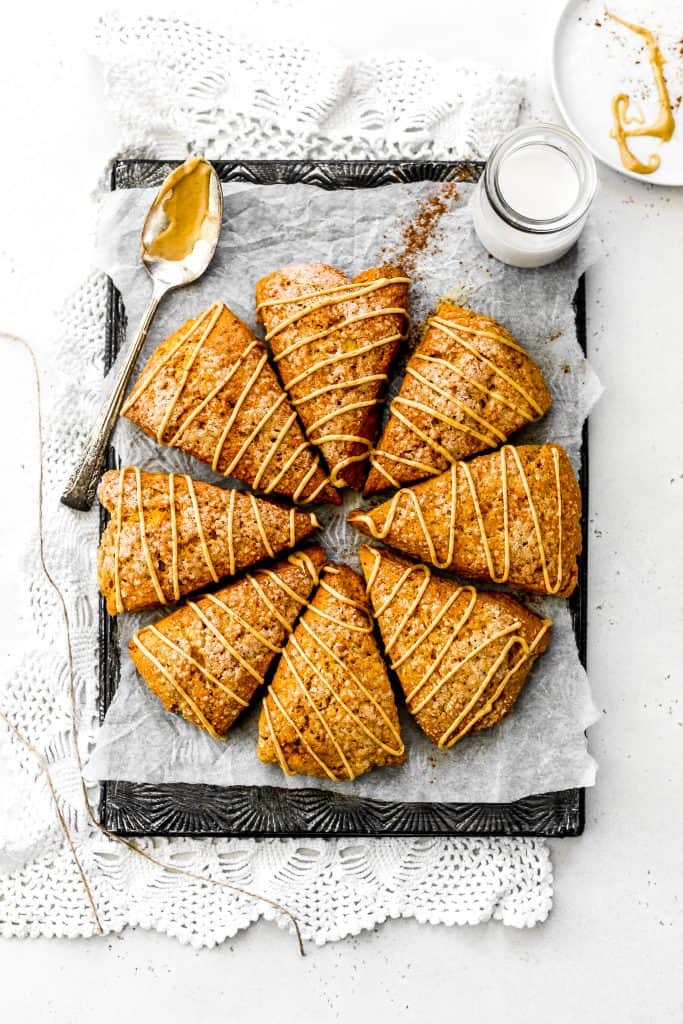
[133,552,318,739]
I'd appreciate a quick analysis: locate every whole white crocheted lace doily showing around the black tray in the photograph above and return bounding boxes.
[0,16,552,946]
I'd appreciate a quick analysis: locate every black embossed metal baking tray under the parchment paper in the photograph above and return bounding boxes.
[99,160,588,838]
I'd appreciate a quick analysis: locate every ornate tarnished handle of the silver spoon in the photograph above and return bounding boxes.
[61,288,168,512]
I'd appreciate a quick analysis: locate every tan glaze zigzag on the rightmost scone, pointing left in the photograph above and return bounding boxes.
[351,444,563,594]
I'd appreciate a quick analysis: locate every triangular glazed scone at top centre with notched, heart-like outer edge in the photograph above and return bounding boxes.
[256,263,410,489]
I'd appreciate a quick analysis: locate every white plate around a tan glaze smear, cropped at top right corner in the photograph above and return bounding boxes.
[552,0,683,185]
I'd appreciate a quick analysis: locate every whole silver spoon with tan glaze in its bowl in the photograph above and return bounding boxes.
[61,157,223,511]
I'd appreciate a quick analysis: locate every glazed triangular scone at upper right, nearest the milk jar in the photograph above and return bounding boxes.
[365,300,552,495]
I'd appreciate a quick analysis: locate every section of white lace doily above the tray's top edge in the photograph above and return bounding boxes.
[95,8,523,160]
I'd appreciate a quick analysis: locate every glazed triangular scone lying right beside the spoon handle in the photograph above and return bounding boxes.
[122,302,339,505]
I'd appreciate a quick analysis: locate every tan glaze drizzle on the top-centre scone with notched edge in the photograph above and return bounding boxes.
[256,278,411,487]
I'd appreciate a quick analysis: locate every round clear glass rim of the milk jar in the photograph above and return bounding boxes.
[482,123,598,234]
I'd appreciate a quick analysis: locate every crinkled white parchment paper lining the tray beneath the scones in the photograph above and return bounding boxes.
[88,182,601,802]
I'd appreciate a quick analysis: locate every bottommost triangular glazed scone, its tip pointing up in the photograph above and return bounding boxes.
[258,565,404,782]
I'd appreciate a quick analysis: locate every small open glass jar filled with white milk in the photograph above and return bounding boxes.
[472,124,597,267]
